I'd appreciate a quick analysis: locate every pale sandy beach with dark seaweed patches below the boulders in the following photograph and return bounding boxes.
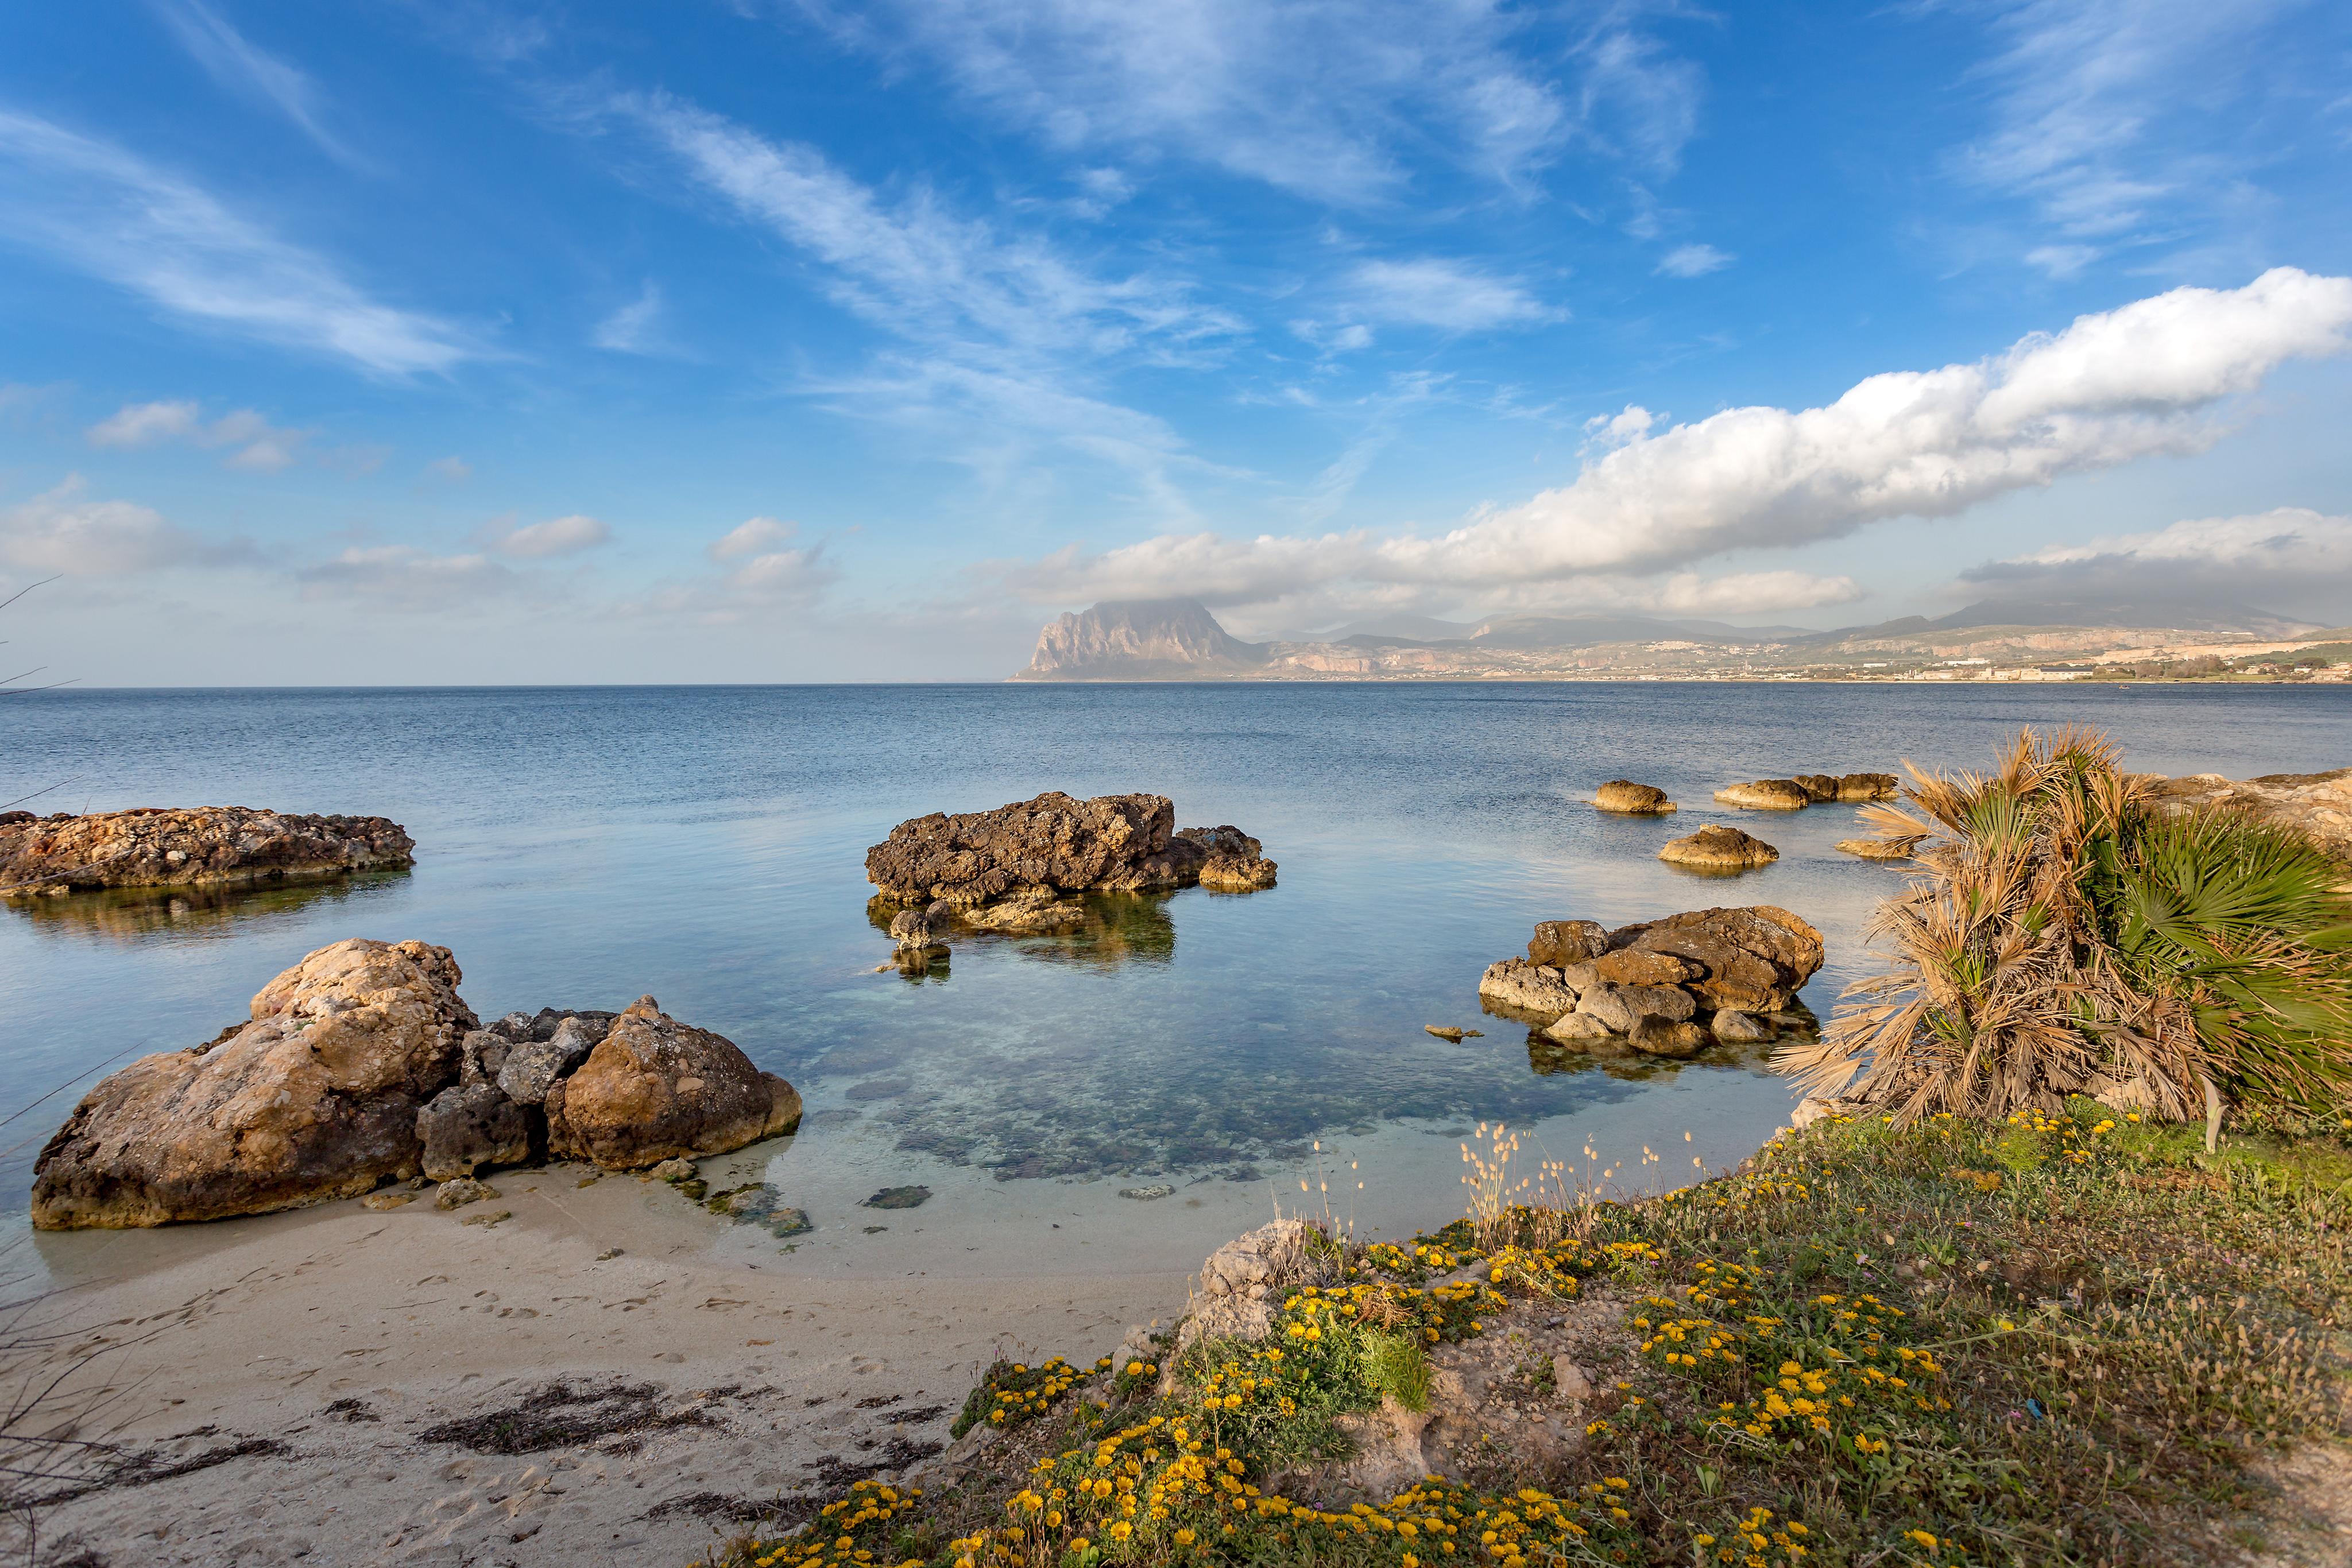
[9,1162,1213,1568]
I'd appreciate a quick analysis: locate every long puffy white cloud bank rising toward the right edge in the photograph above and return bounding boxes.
[1007,268,2352,604]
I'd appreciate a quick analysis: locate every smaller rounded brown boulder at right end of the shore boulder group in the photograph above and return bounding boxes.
[546,997,800,1171]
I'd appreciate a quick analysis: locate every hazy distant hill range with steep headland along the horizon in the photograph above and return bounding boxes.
[1013,599,2319,682]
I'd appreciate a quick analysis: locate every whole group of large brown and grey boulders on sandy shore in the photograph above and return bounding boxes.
[33,938,800,1229]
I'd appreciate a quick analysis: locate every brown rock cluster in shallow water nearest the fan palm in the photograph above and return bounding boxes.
[1479,905,1823,1058]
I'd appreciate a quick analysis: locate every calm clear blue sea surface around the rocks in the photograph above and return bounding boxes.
[0,684,2352,1267]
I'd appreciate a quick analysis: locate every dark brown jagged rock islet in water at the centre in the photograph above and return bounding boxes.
[865,790,1277,962]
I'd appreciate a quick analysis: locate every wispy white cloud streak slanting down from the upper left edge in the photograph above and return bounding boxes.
[0,110,482,376]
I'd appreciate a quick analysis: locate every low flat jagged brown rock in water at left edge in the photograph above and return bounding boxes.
[0,806,416,898]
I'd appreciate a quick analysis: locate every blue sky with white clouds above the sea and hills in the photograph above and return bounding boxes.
[0,0,2352,684]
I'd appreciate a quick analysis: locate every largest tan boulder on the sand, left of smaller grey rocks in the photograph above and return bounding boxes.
[33,938,475,1229]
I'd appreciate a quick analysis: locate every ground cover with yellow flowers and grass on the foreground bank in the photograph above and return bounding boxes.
[701,1100,2352,1568]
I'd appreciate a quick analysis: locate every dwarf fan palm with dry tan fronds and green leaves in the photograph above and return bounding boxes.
[1778,729,2352,1121]
